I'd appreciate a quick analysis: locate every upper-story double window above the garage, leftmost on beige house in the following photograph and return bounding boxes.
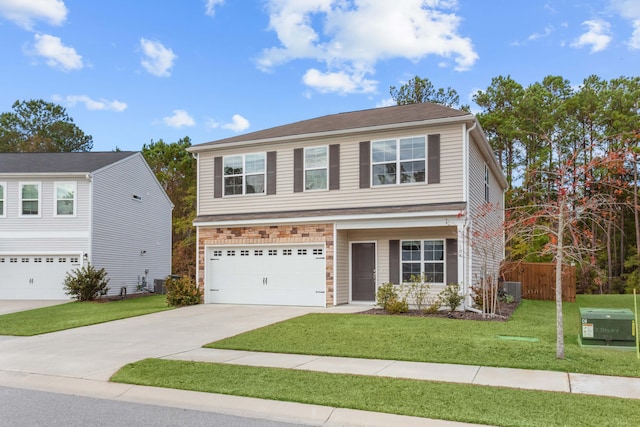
[223,153,266,196]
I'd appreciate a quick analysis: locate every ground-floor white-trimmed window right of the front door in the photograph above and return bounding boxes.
[401,240,445,284]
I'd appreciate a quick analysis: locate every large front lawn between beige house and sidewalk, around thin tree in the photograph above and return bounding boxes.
[205,295,640,377]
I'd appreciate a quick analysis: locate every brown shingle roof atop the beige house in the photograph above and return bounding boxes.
[188,102,474,151]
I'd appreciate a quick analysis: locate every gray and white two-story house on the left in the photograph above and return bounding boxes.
[0,152,173,299]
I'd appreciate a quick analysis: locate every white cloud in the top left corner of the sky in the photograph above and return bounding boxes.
[0,0,67,30]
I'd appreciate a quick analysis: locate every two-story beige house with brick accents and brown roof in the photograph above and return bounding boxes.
[189,103,507,306]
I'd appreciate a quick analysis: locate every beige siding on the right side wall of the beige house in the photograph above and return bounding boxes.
[469,134,504,285]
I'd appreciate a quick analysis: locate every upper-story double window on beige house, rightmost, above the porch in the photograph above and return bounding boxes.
[371,136,426,186]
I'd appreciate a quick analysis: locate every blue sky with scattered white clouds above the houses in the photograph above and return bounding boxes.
[0,0,640,151]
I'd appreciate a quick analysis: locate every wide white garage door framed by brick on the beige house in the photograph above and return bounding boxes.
[205,244,326,307]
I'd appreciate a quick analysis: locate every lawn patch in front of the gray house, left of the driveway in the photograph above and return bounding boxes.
[0,295,173,336]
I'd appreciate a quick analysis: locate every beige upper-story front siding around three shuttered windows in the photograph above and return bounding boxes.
[198,125,464,215]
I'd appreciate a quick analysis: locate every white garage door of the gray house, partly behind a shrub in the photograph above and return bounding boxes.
[0,255,81,300]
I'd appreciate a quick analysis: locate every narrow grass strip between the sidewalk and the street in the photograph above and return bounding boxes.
[112,359,640,426]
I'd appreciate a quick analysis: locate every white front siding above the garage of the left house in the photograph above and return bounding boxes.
[0,176,90,253]
